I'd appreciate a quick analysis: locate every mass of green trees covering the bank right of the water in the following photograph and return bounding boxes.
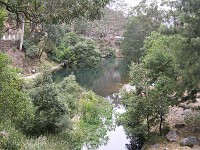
[119,0,200,146]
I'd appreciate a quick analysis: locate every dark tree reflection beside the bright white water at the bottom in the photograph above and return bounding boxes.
[126,135,145,150]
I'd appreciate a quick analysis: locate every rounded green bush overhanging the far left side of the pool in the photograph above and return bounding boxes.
[57,32,100,68]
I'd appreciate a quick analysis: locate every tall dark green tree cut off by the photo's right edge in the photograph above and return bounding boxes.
[174,0,200,100]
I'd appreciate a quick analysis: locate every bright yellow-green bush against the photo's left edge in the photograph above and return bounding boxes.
[0,53,32,121]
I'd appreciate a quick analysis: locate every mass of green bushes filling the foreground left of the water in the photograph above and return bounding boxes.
[0,56,112,149]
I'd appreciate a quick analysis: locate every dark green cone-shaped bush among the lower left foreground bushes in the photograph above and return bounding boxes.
[24,71,69,135]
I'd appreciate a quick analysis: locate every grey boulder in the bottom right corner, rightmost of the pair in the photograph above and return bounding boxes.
[180,136,200,147]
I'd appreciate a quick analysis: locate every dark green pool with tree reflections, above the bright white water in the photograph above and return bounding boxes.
[53,59,127,96]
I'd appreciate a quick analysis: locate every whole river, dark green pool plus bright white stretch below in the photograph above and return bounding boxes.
[53,58,132,150]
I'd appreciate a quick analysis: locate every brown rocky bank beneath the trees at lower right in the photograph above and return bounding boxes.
[144,93,200,150]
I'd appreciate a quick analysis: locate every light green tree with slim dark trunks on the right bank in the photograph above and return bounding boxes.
[120,33,177,139]
